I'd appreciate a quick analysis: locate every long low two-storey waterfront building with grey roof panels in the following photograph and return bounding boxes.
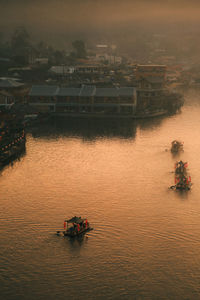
[28,85,137,115]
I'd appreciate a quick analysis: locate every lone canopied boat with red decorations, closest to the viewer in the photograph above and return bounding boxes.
[63,216,93,237]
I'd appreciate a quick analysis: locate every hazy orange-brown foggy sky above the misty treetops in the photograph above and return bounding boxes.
[0,0,200,46]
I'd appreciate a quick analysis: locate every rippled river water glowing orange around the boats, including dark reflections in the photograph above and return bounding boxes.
[0,91,200,300]
